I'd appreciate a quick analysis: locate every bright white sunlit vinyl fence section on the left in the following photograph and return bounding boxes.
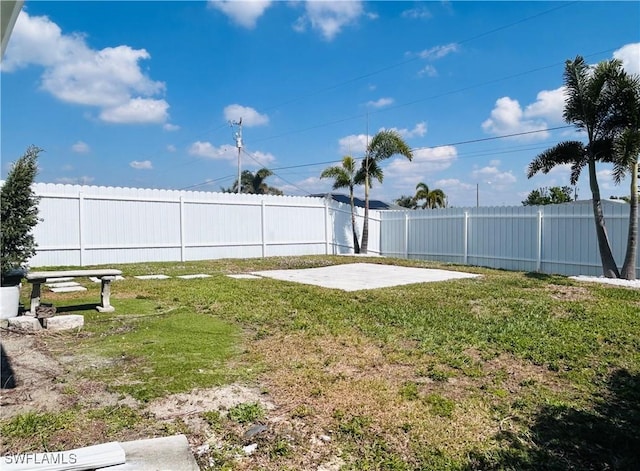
[30,184,379,266]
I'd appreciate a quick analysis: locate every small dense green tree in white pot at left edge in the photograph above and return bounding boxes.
[0,146,42,285]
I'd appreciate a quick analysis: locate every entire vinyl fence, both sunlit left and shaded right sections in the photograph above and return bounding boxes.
[17,183,640,276]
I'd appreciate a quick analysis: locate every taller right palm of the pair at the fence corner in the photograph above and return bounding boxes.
[356,129,413,253]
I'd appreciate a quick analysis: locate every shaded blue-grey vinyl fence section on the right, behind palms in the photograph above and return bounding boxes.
[380,200,640,276]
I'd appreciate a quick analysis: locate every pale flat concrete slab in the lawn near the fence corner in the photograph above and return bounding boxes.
[252,263,480,291]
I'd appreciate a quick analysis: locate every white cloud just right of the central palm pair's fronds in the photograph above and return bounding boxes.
[384,146,458,185]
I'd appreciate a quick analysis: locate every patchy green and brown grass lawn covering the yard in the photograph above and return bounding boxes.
[0,256,640,470]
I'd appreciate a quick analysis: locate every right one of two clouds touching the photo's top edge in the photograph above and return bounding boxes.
[293,0,364,41]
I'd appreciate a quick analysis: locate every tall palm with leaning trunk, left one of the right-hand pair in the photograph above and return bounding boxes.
[527,56,622,278]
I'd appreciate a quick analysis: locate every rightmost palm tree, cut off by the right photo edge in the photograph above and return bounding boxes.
[613,73,640,280]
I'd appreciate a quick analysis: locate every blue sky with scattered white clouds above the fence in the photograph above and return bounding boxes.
[0,0,640,206]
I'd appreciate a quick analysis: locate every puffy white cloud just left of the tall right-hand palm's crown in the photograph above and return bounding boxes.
[482,97,549,140]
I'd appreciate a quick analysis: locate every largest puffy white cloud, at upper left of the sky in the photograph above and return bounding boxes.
[2,10,169,123]
